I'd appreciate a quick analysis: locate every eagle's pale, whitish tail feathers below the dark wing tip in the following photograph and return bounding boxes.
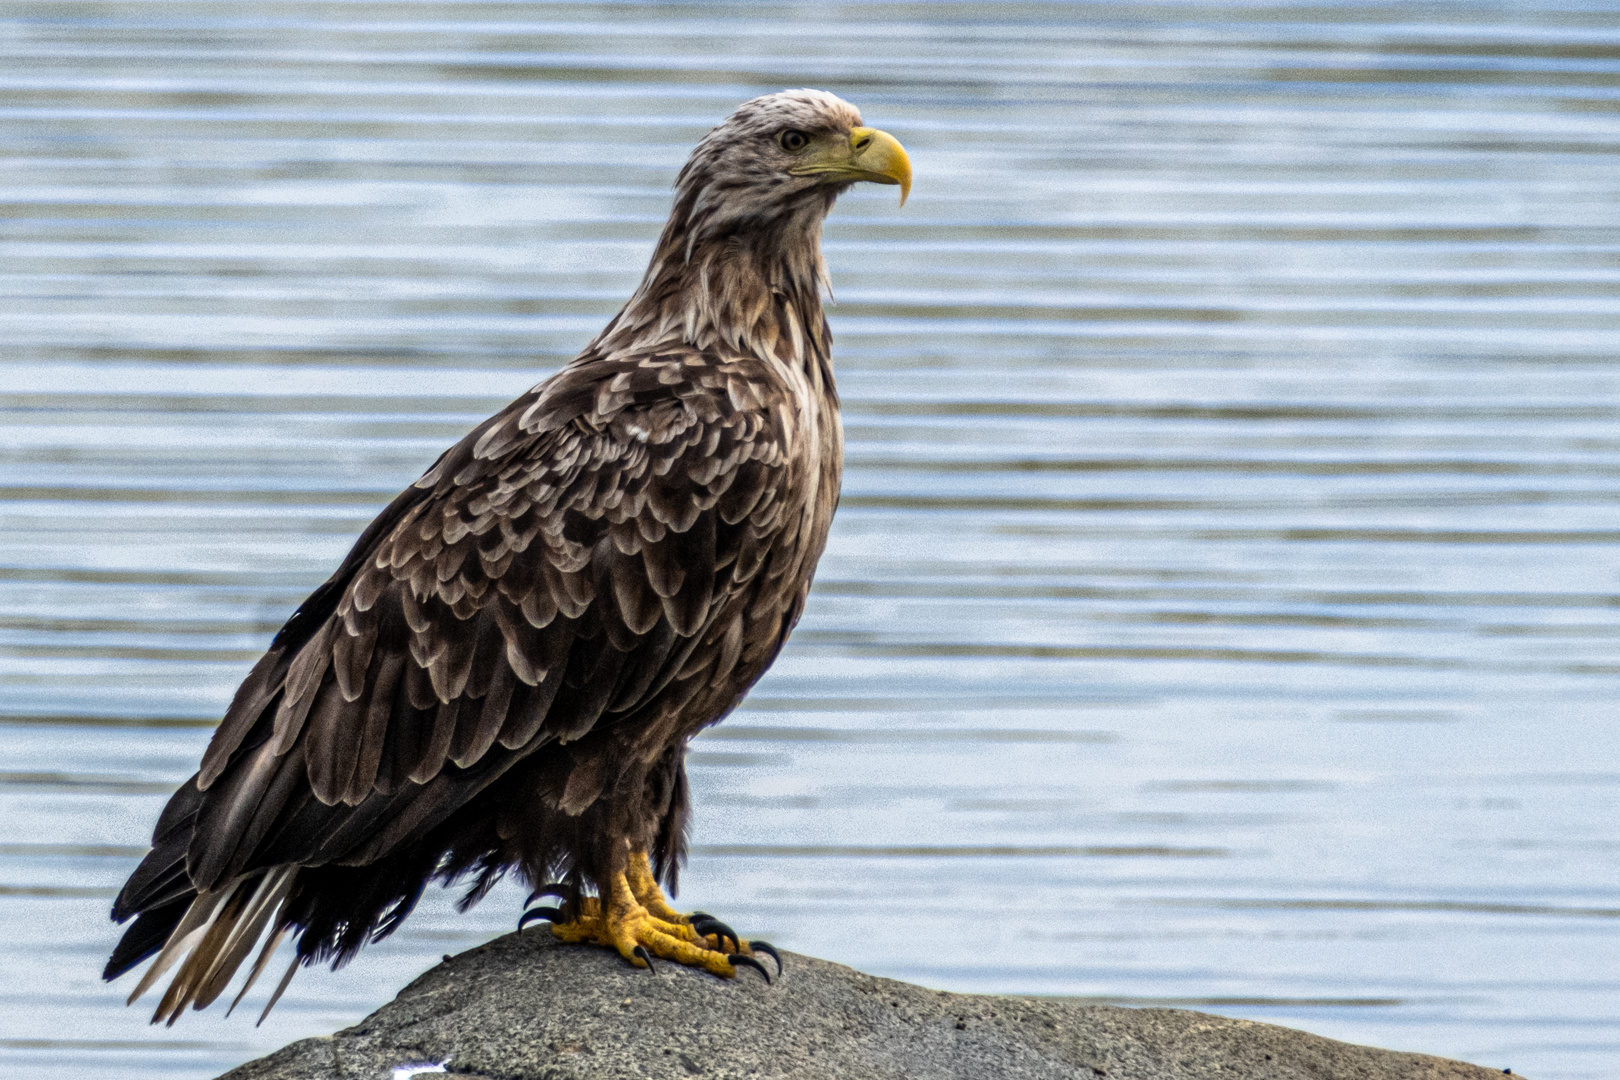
[119,865,298,1025]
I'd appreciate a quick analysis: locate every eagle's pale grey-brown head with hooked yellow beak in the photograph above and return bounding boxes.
[676,91,910,243]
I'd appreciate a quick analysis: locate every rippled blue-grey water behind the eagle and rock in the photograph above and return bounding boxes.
[0,0,1620,1080]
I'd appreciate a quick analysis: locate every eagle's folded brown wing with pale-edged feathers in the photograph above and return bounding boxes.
[115,351,804,916]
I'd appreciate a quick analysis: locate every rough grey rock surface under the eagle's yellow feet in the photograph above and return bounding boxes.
[220,926,1502,1080]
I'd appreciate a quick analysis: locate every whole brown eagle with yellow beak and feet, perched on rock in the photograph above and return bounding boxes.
[104,89,910,1023]
